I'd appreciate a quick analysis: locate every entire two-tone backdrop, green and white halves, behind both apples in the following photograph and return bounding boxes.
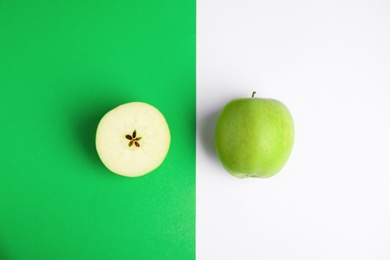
[0,0,390,260]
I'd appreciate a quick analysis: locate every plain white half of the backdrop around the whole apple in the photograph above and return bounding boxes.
[197,0,390,260]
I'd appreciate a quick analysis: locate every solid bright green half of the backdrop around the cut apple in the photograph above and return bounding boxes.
[0,0,196,259]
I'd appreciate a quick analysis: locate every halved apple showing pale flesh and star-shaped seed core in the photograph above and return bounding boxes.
[96,102,171,177]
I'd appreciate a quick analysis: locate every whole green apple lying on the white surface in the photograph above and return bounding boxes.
[214,97,294,178]
